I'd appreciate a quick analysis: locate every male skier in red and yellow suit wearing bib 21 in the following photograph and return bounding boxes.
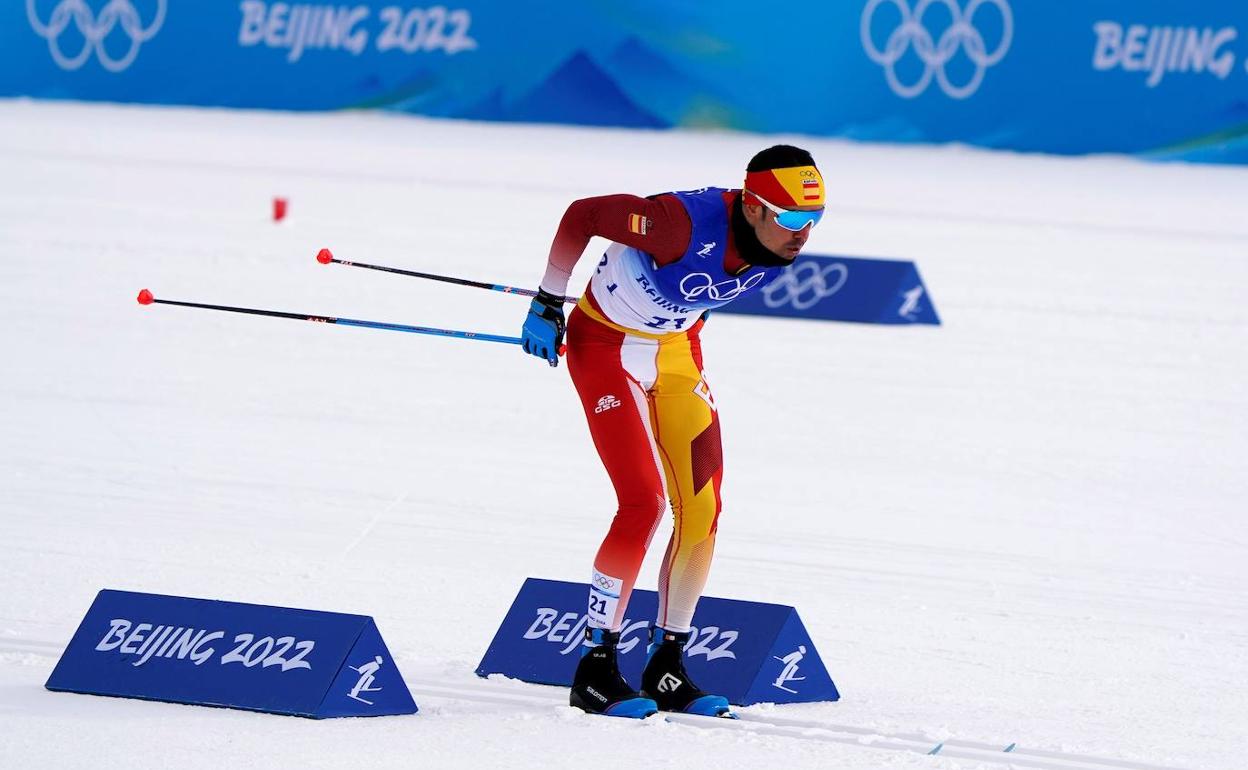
[522,145,825,718]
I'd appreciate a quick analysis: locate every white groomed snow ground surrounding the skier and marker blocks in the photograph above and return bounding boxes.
[0,101,1248,770]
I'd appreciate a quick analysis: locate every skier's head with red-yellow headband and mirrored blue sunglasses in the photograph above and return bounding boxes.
[741,145,826,260]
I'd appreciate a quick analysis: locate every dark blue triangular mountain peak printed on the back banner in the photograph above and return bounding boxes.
[503,51,671,129]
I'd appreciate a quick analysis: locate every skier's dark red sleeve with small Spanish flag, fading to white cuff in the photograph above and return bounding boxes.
[542,195,693,295]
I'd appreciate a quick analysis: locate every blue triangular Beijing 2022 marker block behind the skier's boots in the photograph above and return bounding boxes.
[477,578,840,705]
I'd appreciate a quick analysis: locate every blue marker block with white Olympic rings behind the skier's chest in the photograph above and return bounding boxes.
[715,255,940,326]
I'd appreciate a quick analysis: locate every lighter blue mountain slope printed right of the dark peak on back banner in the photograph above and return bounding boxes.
[603,36,750,130]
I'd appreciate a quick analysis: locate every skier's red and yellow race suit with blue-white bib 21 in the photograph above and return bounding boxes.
[543,188,782,631]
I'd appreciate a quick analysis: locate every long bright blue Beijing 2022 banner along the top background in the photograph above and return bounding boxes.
[0,0,1248,162]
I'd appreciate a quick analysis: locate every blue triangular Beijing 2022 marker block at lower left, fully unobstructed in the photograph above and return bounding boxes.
[46,590,417,718]
